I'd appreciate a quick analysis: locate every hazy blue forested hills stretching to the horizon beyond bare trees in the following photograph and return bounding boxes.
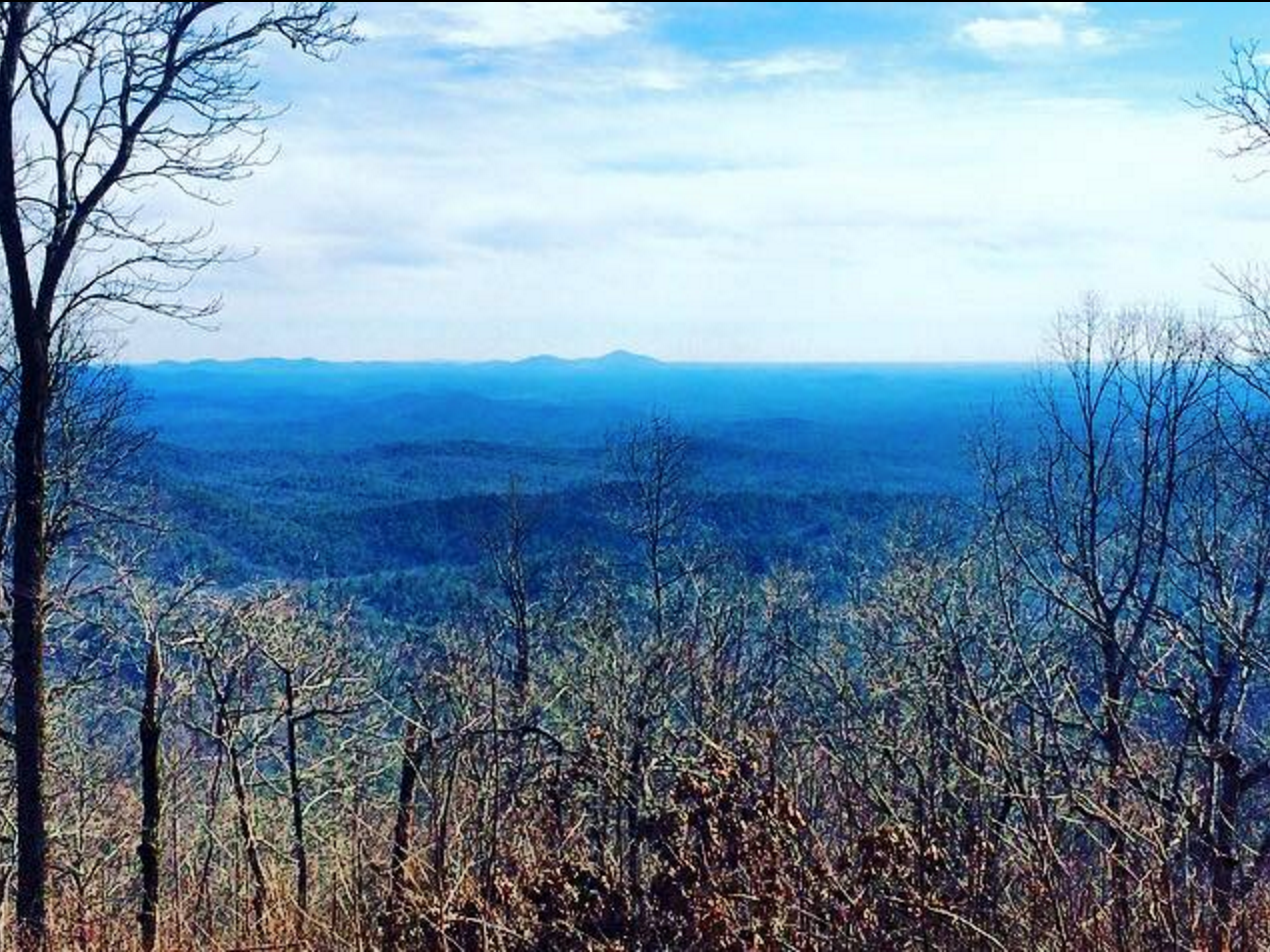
[128,352,1036,614]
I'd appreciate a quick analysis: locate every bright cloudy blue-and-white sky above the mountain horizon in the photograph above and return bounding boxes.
[123,3,1270,360]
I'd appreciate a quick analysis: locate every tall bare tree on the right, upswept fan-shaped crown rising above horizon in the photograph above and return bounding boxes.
[989,298,1213,948]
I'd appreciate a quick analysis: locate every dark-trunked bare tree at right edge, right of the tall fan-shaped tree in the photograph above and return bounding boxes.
[1158,385,1270,949]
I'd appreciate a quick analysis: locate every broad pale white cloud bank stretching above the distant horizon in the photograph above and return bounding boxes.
[128,44,1270,368]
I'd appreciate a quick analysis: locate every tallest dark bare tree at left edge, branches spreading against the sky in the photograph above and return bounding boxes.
[0,3,349,944]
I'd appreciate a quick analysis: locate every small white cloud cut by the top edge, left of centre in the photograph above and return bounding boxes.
[359,3,638,50]
